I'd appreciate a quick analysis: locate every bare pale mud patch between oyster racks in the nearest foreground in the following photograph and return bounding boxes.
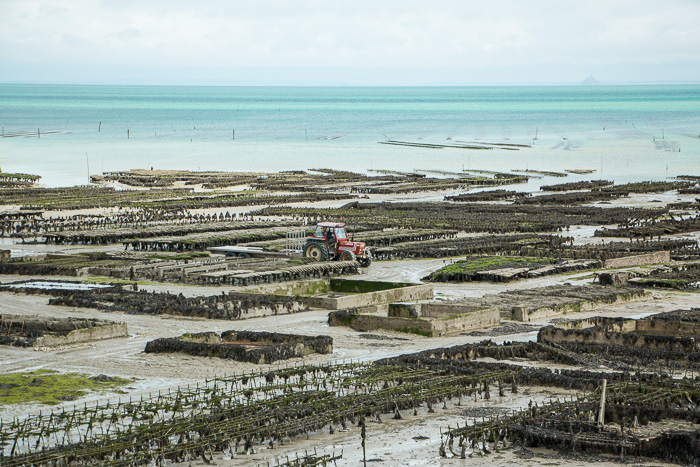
[219,388,674,467]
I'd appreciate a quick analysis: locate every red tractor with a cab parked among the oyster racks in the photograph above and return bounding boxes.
[303,222,372,268]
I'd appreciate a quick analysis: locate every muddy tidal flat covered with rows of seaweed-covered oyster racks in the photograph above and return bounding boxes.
[0,169,700,465]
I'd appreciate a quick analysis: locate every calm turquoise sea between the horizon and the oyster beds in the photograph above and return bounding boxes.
[0,85,700,186]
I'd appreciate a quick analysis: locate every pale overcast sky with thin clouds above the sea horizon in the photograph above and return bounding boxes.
[0,0,700,85]
